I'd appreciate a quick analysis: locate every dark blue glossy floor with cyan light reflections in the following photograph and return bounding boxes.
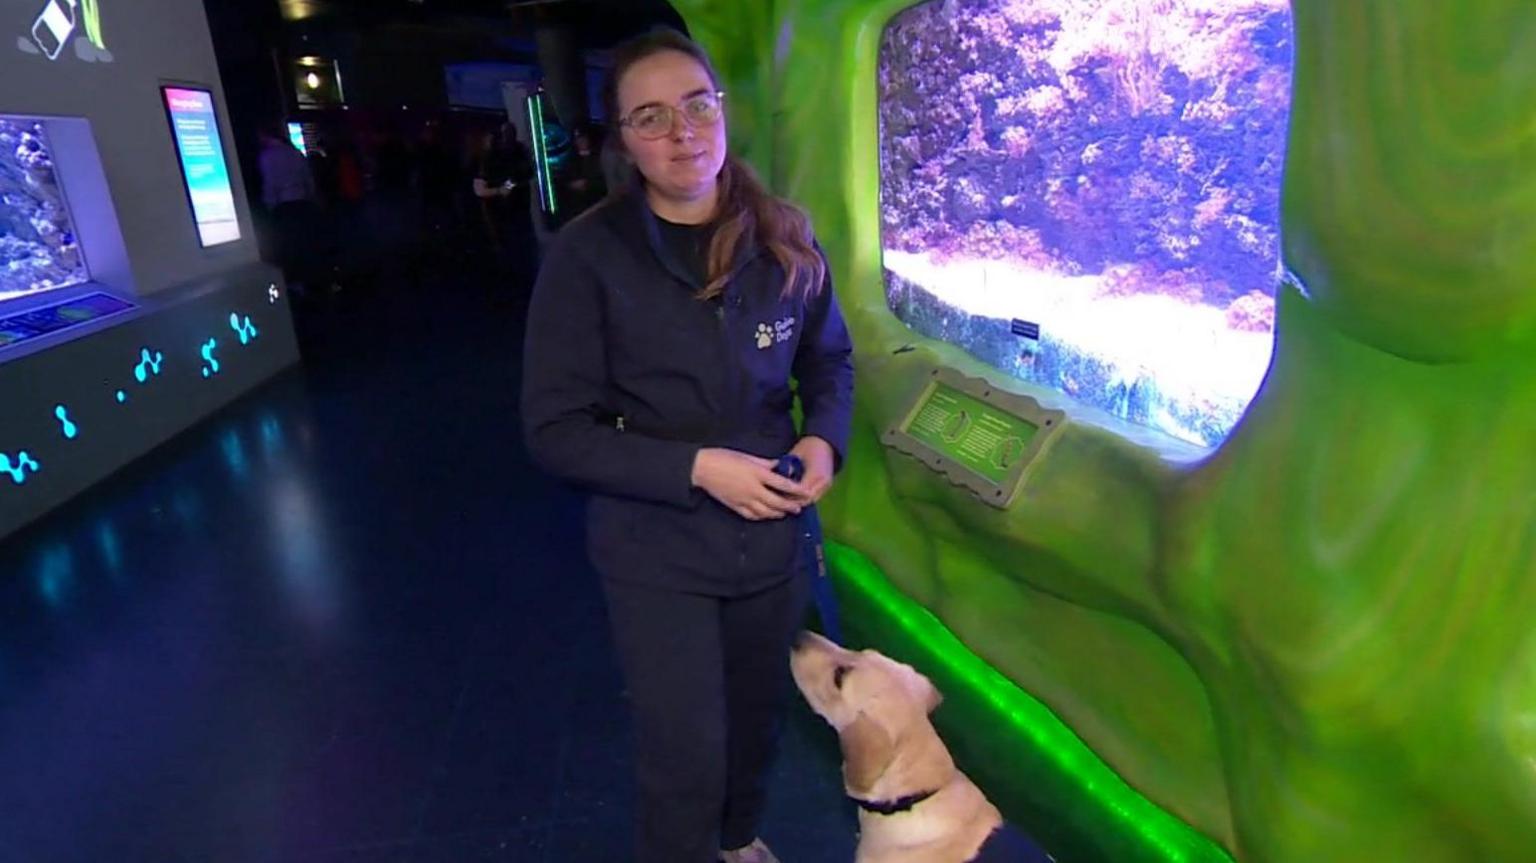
[0,247,856,863]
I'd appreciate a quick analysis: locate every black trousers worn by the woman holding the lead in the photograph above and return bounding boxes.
[604,573,809,863]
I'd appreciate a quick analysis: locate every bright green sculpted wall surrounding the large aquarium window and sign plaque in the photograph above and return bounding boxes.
[674,0,1536,863]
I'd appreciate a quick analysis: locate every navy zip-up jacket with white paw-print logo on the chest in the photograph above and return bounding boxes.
[522,192,854,596]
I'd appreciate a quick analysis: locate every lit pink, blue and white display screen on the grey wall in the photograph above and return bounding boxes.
[161,88,240,247]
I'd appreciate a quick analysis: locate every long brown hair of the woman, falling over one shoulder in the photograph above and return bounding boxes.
[604,28,826,299]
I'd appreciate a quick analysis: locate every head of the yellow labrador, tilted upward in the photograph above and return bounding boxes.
[790,633,954,799]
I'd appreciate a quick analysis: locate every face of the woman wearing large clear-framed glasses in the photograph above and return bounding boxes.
[619,51,725,201]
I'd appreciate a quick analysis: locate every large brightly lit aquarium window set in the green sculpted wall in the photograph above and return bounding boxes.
[879,0,1292,445]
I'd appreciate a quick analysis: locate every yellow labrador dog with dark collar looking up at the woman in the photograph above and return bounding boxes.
[791,633,1003,863]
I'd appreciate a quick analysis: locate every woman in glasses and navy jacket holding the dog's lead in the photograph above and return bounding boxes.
[522,31,852,863]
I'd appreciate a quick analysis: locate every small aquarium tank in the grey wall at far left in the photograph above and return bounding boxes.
[0,115,88,301]
